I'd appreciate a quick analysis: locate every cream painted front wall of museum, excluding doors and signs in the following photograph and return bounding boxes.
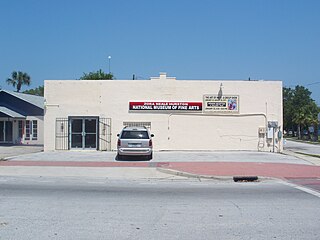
[44,75,282,151]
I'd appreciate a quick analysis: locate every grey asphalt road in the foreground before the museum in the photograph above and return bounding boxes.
[0,177,320,240]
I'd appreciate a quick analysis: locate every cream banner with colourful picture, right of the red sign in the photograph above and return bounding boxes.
[203,94,239,113]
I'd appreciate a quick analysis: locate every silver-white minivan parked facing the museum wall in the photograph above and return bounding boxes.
[117,127,154,160]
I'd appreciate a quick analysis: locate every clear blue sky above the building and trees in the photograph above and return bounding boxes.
[0,0,320,105]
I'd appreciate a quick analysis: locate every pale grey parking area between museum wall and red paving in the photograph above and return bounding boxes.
[1,149,311,164]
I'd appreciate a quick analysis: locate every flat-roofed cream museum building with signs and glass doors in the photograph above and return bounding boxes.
[44,73,283,152]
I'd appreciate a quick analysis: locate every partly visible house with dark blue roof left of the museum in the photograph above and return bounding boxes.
[0,90,44,145]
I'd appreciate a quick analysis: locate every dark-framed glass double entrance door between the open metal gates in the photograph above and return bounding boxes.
[70,118,98,149]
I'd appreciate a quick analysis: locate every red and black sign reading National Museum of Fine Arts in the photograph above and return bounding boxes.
[129,101,202,112]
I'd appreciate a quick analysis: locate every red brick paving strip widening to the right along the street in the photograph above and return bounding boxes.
[0,161,320,179]
